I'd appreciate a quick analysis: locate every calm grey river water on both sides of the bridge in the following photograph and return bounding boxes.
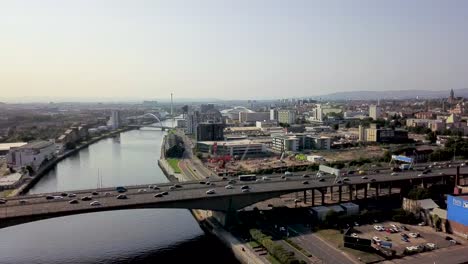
[0,121,238,264]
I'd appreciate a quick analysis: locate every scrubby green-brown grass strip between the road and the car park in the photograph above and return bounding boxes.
[315,229,384,263]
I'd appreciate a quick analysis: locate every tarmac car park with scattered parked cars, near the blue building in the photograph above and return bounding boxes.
[354,221,460,255]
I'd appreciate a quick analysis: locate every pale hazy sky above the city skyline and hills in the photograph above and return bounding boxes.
[0,0,468,99]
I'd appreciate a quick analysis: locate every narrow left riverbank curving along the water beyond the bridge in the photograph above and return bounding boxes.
[13,127,134,197]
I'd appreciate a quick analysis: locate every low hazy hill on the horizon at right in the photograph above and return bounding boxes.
[313,88,468,100]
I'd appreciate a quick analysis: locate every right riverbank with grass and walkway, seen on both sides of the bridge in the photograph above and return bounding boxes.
[158,134,268,264]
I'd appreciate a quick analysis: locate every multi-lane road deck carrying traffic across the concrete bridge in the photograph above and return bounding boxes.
[0,167,468,227]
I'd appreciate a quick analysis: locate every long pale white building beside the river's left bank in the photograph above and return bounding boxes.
[6,141,55,170]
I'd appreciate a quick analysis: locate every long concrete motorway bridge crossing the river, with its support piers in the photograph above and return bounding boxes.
[0,167,468,228]
